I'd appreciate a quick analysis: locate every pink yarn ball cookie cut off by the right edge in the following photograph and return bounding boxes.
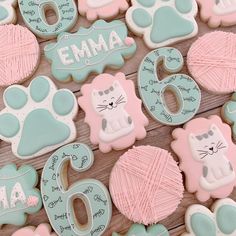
[187,31,236,94]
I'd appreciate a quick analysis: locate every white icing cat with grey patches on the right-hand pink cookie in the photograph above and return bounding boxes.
[189,124,235,191]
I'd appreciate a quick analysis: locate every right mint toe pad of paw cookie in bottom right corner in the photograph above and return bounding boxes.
[216,205,236,235]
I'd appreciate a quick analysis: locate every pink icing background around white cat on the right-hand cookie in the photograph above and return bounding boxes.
[171,115,236,202]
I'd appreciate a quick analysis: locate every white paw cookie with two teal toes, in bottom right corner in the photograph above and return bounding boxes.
[182,198,236,236]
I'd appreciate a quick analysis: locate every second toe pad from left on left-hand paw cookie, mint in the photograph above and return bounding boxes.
[4,87,28,110]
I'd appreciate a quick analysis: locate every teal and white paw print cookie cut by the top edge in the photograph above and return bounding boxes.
[126,0,198,49]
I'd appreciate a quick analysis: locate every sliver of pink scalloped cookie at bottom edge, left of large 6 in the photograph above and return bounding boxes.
[12,224,57,236]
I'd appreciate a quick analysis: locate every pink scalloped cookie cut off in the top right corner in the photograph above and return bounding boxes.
[197,0,236,28]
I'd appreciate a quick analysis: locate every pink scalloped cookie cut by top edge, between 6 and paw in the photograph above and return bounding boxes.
[78,0,129,21]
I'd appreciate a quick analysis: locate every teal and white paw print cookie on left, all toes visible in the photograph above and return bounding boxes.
[0,76,78,159]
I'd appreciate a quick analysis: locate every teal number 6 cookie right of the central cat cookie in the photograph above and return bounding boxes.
[138,48,201,125]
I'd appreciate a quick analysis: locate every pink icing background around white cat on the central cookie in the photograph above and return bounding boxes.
[78,73,148,153]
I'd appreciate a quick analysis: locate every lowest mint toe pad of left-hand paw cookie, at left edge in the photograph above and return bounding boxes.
[0,113,20,138]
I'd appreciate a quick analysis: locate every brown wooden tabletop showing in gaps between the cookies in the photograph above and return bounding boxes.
[0,3,236,236]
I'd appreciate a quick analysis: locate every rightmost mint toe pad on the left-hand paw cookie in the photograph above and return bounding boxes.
[52,90,74,116]
